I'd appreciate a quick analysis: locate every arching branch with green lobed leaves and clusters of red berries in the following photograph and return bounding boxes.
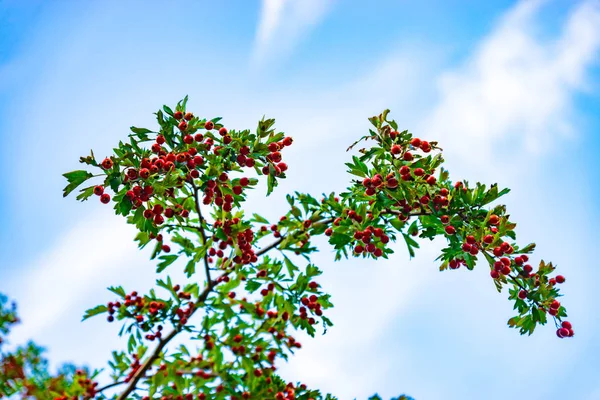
[0,97,573,400]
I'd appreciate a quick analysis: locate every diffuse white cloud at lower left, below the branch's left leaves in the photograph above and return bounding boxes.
[8,209,138,340]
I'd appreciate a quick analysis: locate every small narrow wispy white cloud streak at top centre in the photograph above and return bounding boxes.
[252,0,333,68]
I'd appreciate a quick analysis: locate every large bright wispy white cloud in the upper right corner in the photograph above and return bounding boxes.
[420,1,600,177]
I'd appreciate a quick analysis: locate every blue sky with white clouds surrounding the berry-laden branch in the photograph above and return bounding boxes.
[0,0,600,400]
